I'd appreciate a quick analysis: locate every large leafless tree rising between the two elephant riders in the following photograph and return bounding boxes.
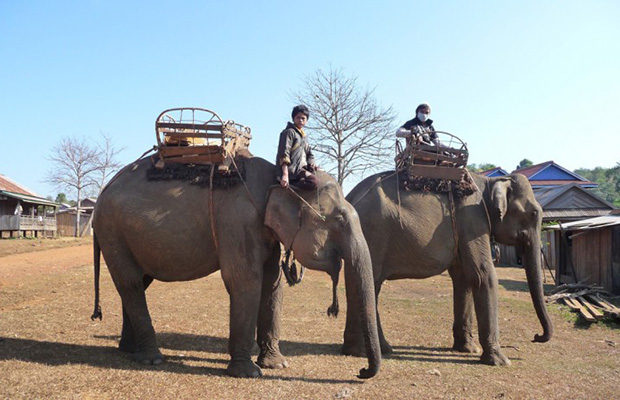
[291,67,395,186]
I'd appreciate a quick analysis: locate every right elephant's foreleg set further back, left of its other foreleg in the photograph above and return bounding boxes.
[448,265,480,353]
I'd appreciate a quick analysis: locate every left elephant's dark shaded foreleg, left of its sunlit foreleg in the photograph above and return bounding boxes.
[221,256,263,378]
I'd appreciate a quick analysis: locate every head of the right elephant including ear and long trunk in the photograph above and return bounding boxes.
[489,174,553,342]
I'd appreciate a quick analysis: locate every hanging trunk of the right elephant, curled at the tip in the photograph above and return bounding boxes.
[523,236,553,343]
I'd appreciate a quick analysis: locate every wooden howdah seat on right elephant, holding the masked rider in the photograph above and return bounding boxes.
[396,131,469,181]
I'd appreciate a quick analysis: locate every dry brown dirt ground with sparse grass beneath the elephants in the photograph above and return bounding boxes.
[0,239,620,399]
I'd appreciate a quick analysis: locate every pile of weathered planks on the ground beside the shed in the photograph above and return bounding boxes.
[547,283,620,322]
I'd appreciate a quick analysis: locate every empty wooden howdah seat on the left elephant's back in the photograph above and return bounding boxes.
[155,108,252,171]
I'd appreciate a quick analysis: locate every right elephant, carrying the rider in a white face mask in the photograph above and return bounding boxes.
[342,171,553,365]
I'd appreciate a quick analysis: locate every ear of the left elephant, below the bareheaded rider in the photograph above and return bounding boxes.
[265,186,301,249]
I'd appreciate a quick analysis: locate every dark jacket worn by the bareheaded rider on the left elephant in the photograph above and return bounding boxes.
[276,122,314,176]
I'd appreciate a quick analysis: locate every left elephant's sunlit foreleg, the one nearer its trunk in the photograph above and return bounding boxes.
[257,246,288,369]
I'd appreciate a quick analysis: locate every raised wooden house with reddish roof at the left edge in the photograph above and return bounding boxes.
[0,174,58,238]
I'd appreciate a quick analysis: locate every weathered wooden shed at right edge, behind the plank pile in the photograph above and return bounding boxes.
[547,210,620,294]
